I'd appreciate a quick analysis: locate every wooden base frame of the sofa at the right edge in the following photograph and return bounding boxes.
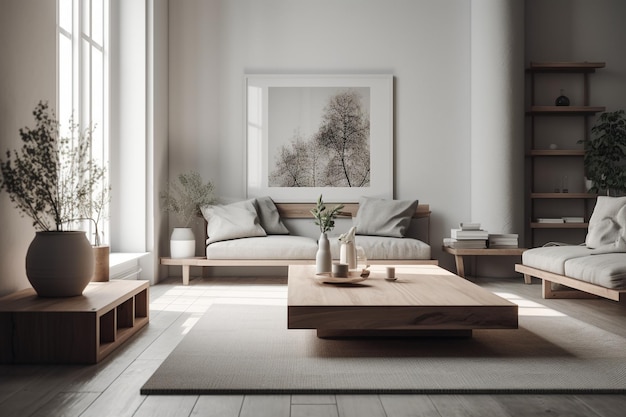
[515,264,626,301]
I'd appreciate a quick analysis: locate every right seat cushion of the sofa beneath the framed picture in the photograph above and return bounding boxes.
[330,235,430,260]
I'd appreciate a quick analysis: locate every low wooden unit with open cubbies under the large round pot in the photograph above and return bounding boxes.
[0,280,149,363]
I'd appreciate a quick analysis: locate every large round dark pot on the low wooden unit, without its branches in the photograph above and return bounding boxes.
[26,231,95,297]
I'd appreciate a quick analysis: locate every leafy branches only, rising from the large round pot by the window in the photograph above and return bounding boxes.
[0,101,105,231]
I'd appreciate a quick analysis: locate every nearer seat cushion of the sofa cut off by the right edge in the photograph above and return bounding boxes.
[565,253,626,289]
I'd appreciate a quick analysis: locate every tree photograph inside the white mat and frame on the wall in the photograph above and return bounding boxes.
[268,87,371,187]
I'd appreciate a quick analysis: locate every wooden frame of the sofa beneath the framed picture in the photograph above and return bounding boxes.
[160,203,439,285]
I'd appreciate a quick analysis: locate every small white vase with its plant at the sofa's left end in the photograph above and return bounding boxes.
[161,171,215,258]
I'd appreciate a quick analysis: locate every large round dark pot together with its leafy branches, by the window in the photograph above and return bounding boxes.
[0,102,104,297]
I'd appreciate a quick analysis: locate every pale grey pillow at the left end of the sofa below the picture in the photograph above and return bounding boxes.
[202,200,267,245]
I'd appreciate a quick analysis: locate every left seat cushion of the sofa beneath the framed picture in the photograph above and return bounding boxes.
[206,235,317,259]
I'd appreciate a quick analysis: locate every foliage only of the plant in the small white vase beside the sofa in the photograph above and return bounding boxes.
[161,171,216,227]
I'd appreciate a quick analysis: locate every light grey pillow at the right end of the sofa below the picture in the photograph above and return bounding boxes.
[354,197,417,237]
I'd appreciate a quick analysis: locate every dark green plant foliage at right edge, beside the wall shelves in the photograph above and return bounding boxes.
[578,110,626,195]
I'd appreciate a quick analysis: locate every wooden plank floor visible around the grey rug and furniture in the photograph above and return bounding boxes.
[0,272,626,417]
